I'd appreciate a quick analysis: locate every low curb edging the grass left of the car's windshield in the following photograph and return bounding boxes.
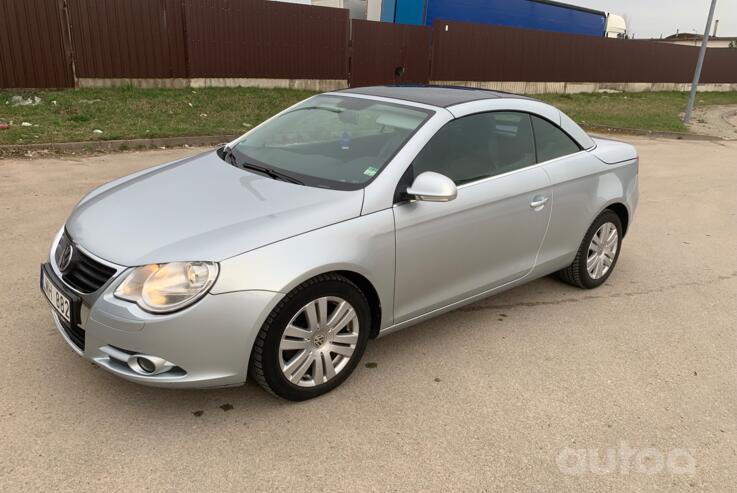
[0,135,237,157]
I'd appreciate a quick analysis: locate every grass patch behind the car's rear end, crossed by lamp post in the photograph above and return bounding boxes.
[539,92,737,132]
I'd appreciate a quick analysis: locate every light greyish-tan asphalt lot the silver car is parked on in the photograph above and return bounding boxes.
[0,138,737,492]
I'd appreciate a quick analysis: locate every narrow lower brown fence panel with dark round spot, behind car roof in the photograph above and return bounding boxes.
[350,20,432,87]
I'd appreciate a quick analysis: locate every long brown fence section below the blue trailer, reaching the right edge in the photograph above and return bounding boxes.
[431,21,737,83]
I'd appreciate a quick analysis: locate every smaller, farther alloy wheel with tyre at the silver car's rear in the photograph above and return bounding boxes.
[558,209,622,289]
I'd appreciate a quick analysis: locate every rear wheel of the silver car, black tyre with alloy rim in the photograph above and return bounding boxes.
[557,209,622,289]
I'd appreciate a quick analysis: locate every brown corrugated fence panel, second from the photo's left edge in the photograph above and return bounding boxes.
[67,0,187,78]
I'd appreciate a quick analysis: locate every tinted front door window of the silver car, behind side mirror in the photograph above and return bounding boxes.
[412,112,535,185]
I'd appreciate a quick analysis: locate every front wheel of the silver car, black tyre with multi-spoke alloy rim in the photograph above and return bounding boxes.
[249,274,371,401]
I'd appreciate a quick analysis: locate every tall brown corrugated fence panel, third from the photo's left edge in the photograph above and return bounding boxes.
[184,0,349,79]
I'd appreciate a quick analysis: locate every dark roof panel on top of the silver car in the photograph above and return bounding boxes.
[337,84,531,108]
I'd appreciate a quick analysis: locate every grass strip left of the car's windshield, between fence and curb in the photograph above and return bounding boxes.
[0,87,314,144]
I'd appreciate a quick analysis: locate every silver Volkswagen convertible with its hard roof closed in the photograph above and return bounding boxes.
[40,86,638,400]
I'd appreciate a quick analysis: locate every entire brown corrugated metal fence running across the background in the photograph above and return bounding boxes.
[0,0,737,88]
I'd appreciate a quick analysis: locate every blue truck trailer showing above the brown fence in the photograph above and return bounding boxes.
[381,0,606,37]
